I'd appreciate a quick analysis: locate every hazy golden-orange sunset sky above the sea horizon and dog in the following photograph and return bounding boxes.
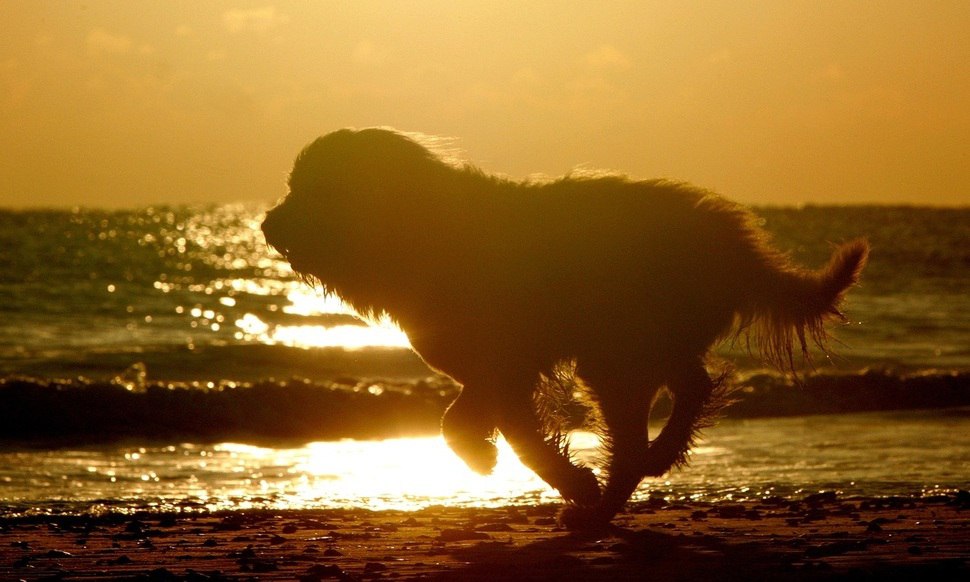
[0,0,970,208]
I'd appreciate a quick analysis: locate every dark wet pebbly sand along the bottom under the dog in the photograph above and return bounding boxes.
[0,492,970,582]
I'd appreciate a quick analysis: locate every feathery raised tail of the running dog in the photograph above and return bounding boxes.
[742,239,869,371]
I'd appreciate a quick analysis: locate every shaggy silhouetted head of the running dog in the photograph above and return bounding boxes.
[262,128,450,300]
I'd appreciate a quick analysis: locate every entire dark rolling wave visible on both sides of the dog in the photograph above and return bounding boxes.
[0,364,970,446]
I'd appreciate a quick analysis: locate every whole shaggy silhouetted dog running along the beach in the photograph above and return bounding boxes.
[263,129,868,526]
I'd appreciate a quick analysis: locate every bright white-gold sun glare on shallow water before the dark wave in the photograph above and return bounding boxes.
[182,437,558,510]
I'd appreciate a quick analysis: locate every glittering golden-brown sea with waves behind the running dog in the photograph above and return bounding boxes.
[0,204,970,516]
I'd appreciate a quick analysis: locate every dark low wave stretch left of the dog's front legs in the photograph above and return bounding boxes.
[0,366,456,446]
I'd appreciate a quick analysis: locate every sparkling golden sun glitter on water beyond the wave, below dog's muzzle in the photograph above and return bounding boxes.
[129,206,410,350]
